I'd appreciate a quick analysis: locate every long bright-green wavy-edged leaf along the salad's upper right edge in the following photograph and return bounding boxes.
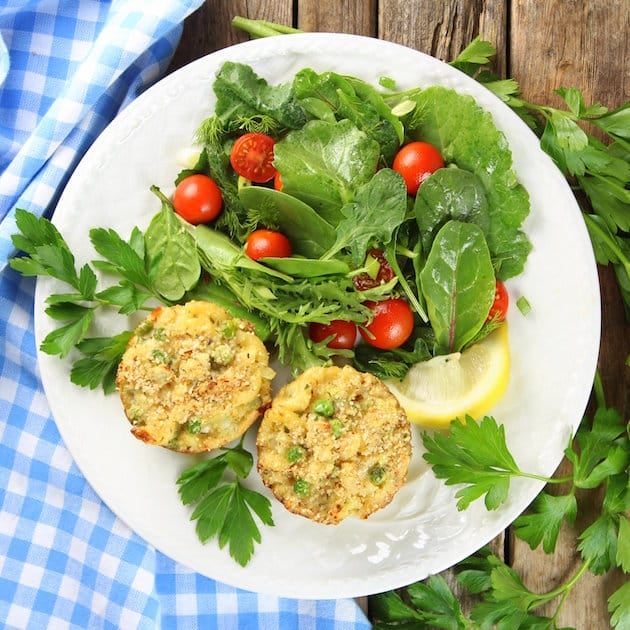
[407,86,531,280]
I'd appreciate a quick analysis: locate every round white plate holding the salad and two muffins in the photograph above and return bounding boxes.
[35,33,600,598]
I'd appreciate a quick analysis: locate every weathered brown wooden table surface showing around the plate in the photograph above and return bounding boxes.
[172,0,630,630]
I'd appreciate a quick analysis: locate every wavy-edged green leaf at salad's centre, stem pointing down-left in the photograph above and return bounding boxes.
[324,168,407,266]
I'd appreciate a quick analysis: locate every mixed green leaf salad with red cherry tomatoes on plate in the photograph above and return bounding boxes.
[147,62,531,386]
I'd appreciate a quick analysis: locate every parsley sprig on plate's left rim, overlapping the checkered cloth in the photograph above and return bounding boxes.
[9,209,160,393]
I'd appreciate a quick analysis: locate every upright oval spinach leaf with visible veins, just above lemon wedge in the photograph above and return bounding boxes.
[420,220,495,354]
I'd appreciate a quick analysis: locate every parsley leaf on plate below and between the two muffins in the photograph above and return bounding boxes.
[177,438,274,566]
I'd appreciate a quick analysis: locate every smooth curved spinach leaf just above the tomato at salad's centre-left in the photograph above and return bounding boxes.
[239,186,335,258]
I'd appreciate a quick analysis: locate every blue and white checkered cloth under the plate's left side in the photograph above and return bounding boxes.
[0,0,370,630]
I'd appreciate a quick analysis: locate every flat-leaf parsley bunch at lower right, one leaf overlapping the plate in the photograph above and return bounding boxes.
[412,378,630,628]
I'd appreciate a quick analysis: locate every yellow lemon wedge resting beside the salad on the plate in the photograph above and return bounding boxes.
[385,323,510,428]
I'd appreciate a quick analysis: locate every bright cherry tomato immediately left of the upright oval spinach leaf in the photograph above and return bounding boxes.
[360,298,414,350]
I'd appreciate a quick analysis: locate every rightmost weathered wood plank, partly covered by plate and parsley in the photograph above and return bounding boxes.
[509,0,630,628]
